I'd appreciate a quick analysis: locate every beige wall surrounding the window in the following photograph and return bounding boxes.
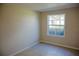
[40,8,79,48]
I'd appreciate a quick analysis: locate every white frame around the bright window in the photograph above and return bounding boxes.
[47,13,66,37]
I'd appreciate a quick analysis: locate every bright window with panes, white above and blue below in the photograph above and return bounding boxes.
[47,14,65,36]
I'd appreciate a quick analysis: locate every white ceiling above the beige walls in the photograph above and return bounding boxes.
[20,3,78,12]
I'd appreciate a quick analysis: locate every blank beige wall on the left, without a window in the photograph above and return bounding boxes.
[1,4,39,55]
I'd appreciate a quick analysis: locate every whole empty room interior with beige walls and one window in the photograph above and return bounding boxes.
[0,3,79,56]
